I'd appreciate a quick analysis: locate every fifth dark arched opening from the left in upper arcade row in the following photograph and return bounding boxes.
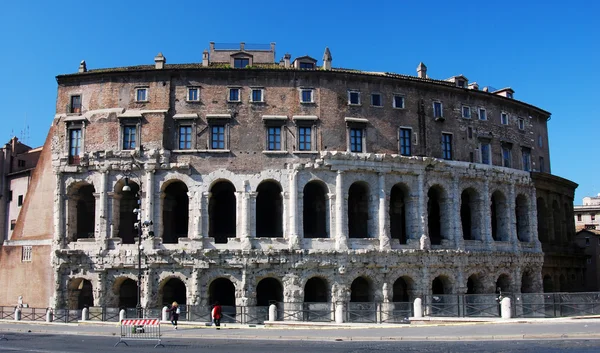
[256,181,283,238]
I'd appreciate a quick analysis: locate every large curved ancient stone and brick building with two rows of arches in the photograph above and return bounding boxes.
[0,43,580,308]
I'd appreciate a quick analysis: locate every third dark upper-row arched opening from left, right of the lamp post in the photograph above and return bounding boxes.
[162,181,189,244]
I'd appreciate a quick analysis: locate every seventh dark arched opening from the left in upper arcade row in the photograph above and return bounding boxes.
[348,182,369,238]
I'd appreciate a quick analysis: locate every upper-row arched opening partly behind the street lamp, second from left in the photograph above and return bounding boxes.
[117,179,140,244]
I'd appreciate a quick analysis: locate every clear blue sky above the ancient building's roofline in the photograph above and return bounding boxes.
[0,0,600,204]
